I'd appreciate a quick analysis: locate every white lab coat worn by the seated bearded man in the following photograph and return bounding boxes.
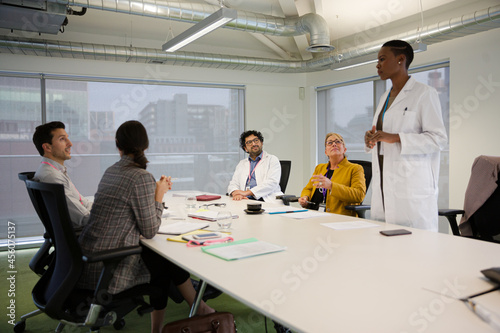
[227,151,283,202]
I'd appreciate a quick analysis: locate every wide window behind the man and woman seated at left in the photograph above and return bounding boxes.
[0,73,244,240]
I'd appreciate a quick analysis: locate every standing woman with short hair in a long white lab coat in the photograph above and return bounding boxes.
[365,40,447,231]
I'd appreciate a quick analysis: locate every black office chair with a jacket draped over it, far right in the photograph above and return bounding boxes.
[439,156,500,243]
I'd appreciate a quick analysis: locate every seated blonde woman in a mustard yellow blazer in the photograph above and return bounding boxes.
[299,133,366,216]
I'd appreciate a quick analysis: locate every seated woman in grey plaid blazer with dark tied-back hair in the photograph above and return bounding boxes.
[79,121,214,333]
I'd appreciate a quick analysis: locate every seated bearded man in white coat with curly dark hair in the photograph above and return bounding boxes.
[227,131,283,201]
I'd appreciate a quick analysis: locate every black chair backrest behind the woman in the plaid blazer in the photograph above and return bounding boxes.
[26,180,83,320]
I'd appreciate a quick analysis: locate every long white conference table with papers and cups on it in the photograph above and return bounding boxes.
[142,192,500,333]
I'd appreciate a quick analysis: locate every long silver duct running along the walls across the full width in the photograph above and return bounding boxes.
[0,6,500,73]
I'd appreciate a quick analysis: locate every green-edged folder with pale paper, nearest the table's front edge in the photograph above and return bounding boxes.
[201,238,286,260]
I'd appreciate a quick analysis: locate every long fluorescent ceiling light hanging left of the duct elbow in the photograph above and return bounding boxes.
[162,8,238,52]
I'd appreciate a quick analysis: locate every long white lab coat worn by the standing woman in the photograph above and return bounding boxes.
[366,77,447,231]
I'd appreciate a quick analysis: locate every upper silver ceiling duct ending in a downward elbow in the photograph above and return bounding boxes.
[47,0,333,52]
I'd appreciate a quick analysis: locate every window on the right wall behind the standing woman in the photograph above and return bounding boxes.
[317,63,450,231]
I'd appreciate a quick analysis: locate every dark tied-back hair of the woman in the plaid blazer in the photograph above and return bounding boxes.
[115,120,149,169]
